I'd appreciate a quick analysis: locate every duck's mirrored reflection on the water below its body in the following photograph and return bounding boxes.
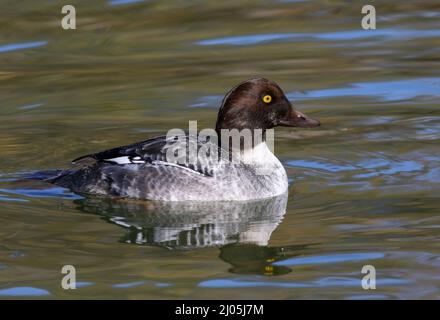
[75,193,304,275]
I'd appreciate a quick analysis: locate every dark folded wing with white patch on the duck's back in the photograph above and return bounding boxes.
[72,135,224,176]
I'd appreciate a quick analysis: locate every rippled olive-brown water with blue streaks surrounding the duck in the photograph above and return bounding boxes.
[0,1,440,299]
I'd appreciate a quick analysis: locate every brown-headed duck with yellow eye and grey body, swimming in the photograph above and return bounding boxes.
[44,78,320,201]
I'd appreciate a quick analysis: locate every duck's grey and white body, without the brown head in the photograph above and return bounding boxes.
[48,137,288,201]
